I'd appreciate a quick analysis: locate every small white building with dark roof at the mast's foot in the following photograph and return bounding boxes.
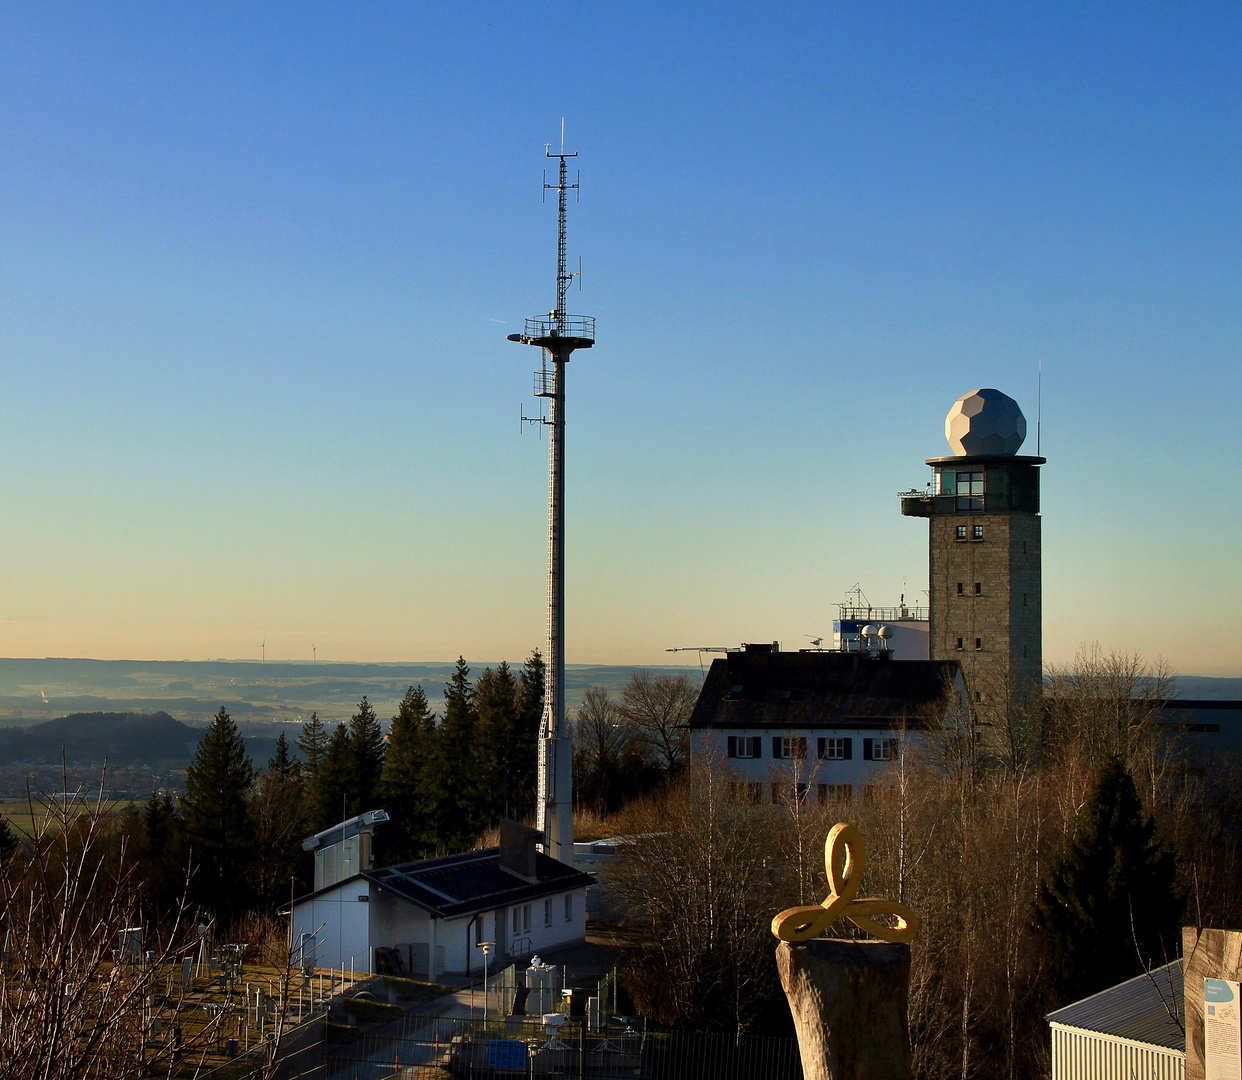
[293,822,595,979]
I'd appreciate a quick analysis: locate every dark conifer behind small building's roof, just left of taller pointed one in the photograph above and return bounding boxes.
[376,686,436,862]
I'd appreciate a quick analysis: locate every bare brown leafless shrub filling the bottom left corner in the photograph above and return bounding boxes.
[0,785,214,1080]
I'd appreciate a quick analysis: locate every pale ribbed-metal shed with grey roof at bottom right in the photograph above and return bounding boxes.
[1045,960,1186,1080]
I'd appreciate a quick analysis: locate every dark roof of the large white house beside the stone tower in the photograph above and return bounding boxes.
[689,652,958,729]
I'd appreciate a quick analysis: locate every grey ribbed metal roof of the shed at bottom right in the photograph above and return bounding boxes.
[1045,960,1186,1050]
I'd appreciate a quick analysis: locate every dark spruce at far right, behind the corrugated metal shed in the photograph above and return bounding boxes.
[1036,755,1181,1002]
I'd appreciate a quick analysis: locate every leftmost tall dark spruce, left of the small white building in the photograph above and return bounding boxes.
[181,705,255,919]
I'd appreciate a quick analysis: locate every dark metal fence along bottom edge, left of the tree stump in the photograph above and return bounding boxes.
[322,1017,802,1080]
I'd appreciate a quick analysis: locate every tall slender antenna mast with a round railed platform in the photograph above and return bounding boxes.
[508,118,595,863]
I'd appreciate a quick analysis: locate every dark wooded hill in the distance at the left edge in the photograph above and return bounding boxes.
[0,713,202,767]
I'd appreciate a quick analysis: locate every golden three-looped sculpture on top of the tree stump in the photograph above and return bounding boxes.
[773,822,919,943]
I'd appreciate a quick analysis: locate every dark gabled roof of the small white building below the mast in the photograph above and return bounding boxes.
[363,848,595,919]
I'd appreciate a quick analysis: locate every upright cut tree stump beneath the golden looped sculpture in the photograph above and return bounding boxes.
[776,937,910,1080]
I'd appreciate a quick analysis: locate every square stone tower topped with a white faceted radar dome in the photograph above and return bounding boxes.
[902,390,1045,706]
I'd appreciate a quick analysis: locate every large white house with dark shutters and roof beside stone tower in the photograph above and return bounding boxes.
[689,644,966,803]
